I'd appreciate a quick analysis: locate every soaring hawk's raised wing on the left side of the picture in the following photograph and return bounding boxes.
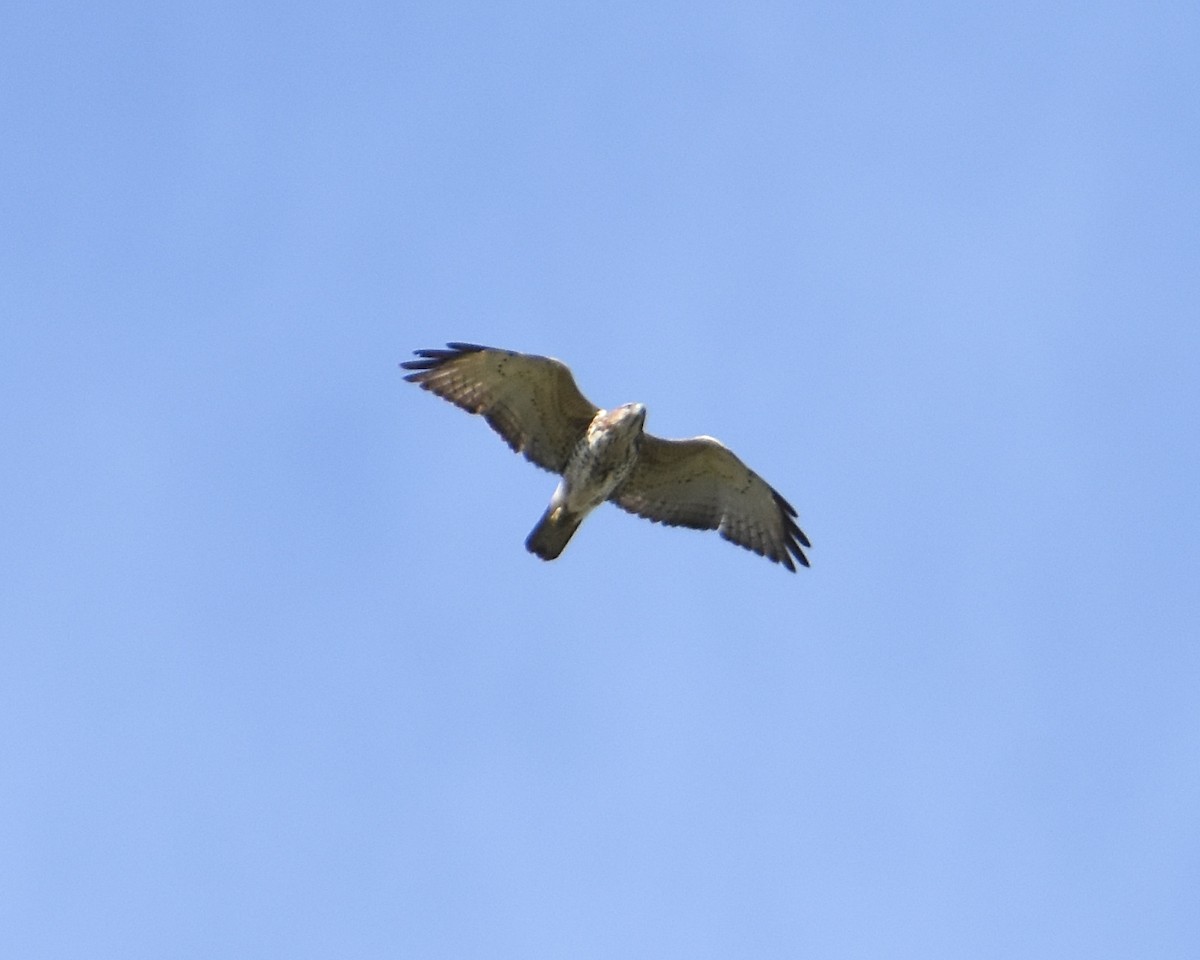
[401,343,599,473]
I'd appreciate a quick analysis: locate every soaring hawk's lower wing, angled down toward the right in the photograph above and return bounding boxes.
[610,434,812,572]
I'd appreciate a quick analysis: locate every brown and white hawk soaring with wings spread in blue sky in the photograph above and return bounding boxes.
[401,343,811,572]
